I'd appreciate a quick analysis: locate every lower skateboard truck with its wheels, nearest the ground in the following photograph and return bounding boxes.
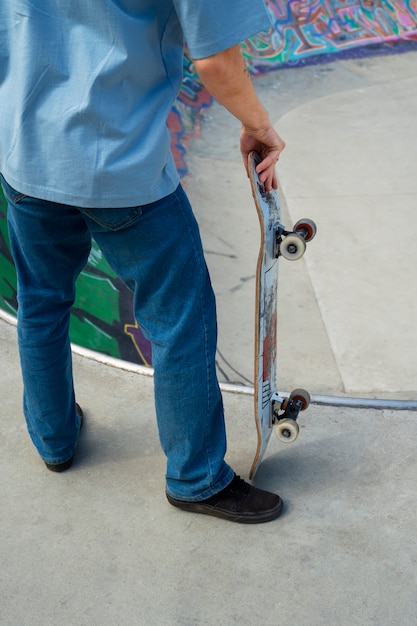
[269,389,310,443]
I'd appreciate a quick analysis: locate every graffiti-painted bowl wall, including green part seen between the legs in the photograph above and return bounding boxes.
[0,0,417,366]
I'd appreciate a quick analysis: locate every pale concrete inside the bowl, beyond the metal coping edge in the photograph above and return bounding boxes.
[187,52,417,399]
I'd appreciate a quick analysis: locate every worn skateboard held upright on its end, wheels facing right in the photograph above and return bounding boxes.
[249,152,317,479]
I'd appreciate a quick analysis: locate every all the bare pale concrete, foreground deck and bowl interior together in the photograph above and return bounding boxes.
[0,47,417,626]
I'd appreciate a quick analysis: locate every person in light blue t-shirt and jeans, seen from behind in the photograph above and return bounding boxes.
[0,0,284,523]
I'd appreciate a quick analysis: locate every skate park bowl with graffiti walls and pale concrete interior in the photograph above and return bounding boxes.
[0,0,417,408]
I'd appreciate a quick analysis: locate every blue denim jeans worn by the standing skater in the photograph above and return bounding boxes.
[2,178,233,501]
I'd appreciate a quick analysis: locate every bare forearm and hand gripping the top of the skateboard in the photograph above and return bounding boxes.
[194,46,285,191]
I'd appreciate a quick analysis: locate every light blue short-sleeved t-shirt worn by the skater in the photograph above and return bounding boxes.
[0,0,270,208]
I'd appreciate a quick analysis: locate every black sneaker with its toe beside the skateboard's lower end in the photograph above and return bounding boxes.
[166,474,282,524]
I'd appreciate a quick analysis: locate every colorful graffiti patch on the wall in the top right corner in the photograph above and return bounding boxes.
[243,0,417,73]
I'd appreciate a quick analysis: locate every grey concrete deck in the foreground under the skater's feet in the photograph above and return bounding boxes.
[0,322,417,626]
